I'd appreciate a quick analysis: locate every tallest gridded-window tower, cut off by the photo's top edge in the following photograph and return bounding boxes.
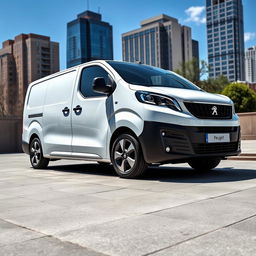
[206,0,245,81]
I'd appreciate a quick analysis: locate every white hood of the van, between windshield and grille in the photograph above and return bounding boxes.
[130,84,233,104]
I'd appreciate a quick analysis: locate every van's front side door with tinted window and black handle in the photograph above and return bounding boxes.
[72,65,113,159]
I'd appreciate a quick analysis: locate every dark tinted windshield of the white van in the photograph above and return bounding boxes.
[107,61,201,91]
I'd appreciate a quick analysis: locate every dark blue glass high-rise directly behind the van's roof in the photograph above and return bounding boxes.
[67,11,113,67]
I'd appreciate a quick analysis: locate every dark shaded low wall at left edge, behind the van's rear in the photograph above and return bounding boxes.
[0,118,22,154]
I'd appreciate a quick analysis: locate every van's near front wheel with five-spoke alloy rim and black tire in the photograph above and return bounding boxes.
[111,134,147,179]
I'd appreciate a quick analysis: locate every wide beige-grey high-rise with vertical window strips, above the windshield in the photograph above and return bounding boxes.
[122,14,199,70]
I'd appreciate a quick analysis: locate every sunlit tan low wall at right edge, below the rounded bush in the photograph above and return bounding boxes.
[238,112,256,140]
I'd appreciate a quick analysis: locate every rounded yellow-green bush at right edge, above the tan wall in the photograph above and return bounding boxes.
[222,83,256,113]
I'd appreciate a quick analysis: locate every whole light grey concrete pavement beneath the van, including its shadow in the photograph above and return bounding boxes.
[0,154,256,256]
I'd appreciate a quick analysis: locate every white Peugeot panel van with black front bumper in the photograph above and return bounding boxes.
[23,61,240,178]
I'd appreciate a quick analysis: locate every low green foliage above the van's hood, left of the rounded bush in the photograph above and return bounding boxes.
[198,75,229,93]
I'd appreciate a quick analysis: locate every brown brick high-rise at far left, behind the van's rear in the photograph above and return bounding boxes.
[0,34,59,116]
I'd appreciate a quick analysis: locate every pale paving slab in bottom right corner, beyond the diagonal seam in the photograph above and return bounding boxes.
[148,217,256,256]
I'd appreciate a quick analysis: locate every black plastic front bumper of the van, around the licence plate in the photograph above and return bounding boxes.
[139,121,241,163]
